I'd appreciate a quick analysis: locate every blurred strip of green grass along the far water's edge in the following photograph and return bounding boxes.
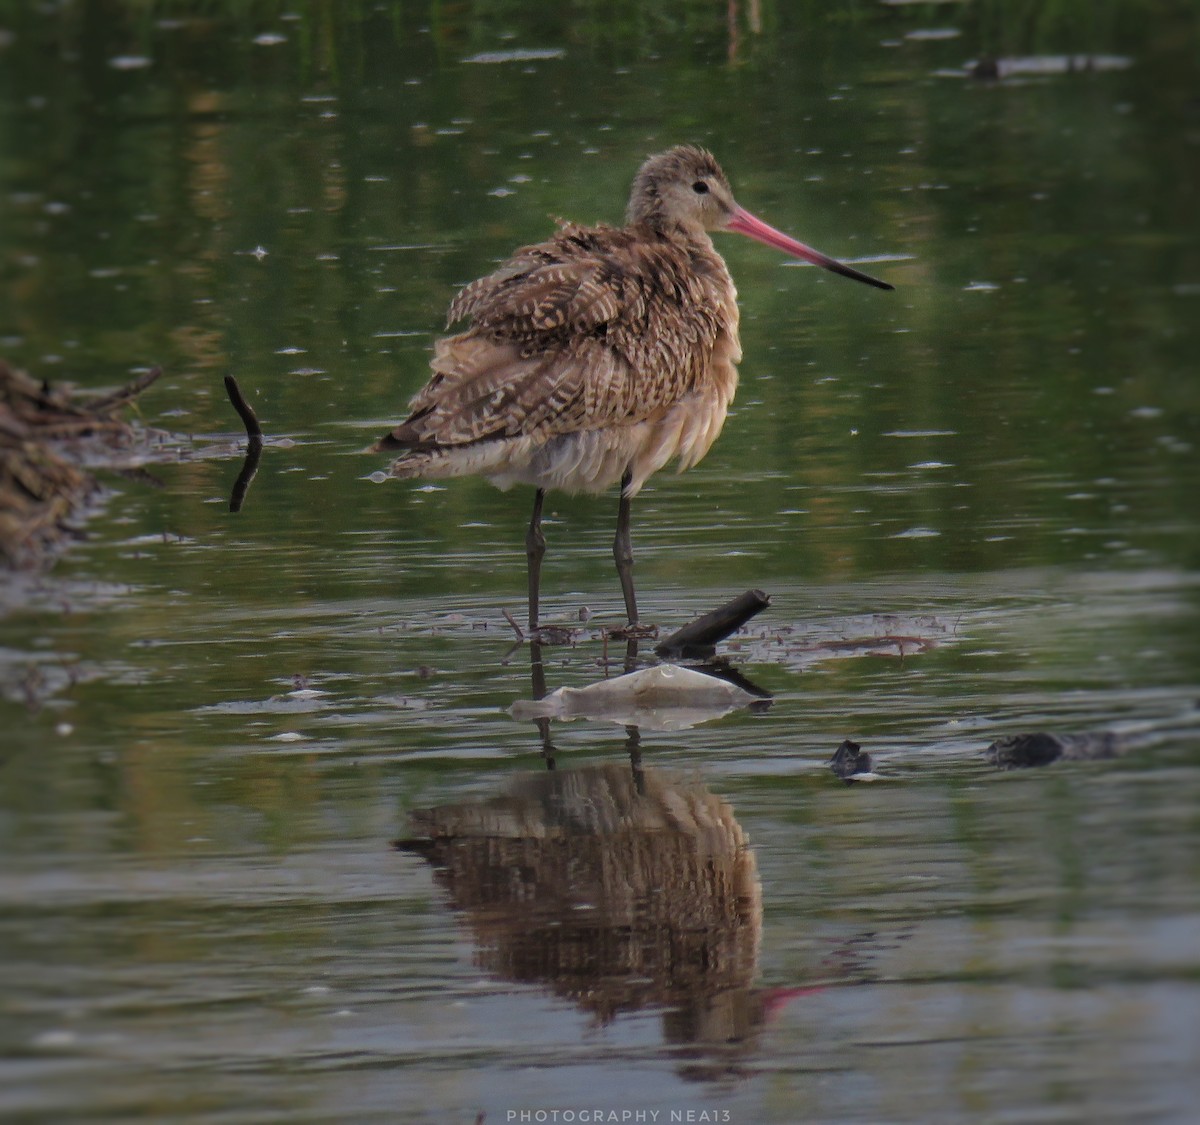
[0,0,1198,72]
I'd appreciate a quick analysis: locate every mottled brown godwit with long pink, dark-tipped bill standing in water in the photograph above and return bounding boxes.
[376,145,892,631]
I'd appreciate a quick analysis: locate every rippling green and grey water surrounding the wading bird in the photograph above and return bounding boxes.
[0,0,1200,1123]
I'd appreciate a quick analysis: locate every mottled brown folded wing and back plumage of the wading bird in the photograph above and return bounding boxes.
[388,228,736,447]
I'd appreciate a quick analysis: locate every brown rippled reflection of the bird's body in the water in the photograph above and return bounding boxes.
[398,748,780,1077]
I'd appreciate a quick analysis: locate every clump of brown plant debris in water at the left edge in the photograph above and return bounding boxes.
[0,360,162,568]
